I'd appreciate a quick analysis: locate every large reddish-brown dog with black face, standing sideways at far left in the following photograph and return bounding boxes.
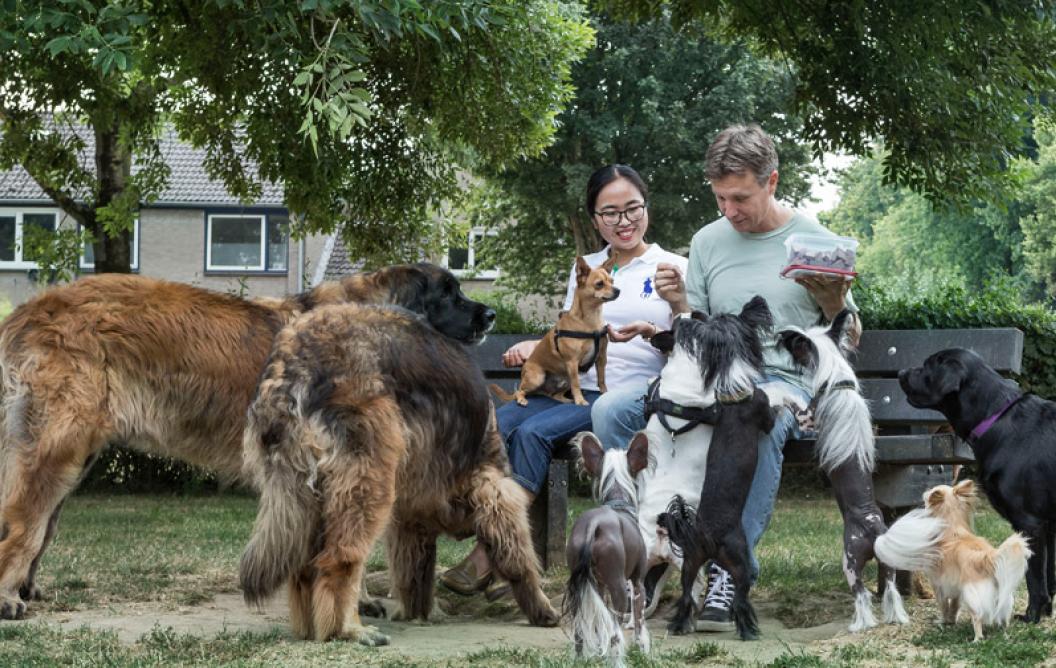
[0,264,494,619]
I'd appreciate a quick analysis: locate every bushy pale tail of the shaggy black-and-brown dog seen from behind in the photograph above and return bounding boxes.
[239,380,321,606]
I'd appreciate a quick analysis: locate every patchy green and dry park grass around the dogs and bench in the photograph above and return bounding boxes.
[0,485,1056,668]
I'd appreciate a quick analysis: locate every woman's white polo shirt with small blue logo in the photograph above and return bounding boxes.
[563,244,689,389]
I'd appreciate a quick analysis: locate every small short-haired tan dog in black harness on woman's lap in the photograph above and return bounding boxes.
[491,257,620,406]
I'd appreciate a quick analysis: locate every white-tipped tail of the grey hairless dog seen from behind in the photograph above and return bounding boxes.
[562,532,626,666]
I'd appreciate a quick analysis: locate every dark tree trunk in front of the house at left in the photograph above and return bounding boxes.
[91,121,132,273]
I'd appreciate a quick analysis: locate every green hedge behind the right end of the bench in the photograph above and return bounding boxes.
[854,280,1056,398]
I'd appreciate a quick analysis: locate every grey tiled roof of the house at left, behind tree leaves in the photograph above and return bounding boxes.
[0,123,283,207]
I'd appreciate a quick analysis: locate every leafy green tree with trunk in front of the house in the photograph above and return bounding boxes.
[0,0,591,271]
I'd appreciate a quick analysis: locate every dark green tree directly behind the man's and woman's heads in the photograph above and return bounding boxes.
[473,11,811,292]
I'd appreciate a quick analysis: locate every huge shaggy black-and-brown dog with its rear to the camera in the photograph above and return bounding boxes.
[241,305,558,645]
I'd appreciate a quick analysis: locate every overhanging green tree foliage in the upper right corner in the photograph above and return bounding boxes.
[595,0,1056,203]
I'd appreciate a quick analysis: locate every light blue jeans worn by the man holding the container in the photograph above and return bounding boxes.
[591,375,810,583]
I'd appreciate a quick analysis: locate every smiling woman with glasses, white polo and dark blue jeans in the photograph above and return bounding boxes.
[440,165,687,600]
